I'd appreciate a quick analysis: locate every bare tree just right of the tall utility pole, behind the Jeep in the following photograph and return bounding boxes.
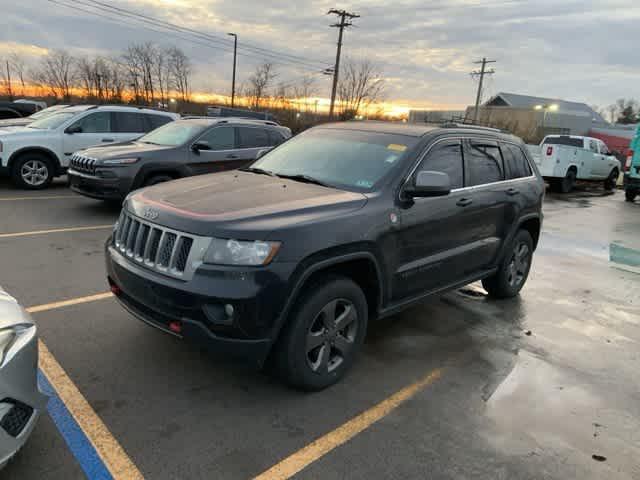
[338,59,384,120]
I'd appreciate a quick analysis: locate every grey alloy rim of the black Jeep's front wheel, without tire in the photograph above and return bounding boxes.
[306,299,359,374]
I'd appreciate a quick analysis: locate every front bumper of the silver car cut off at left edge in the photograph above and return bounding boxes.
[0,322,47,468]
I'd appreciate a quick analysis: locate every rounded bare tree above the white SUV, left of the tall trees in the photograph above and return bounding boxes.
[32,50,76,101]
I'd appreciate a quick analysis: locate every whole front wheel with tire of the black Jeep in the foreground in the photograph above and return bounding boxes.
[274,275,368,391]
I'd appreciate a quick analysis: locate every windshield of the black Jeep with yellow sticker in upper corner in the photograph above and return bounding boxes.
[252,128,419,191]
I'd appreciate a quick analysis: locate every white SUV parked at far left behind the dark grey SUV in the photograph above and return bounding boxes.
[0,105,180,190]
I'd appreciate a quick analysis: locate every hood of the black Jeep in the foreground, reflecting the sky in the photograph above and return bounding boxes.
[127,171,367,240]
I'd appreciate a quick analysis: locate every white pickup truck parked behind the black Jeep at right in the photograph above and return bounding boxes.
[534,135,621,193]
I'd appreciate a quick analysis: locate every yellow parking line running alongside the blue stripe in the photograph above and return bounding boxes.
[38,340,144,480]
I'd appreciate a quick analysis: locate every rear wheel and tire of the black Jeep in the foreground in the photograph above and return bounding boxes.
[482,230,533,298]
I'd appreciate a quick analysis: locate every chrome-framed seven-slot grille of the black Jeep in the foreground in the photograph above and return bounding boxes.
[113,210,195,278]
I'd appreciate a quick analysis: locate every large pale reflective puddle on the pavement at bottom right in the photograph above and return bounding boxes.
[485,350,640,478]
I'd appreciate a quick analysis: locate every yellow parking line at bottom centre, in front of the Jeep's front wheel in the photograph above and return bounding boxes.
[254,369,442,480]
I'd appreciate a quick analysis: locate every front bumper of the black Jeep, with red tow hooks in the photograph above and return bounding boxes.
[106,239,295,365]
